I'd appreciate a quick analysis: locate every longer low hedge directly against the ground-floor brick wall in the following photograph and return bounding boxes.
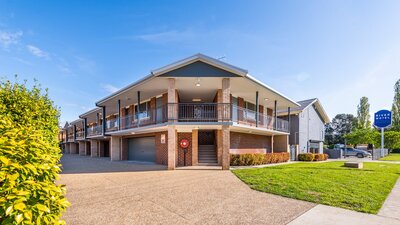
[230,152,289,166]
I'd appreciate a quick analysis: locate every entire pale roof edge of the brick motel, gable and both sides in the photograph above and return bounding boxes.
[95,53,300,108]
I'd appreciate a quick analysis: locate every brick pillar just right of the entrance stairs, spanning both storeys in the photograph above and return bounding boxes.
[221,78,231,170]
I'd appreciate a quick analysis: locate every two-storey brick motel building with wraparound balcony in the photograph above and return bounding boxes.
[60,54,299,169]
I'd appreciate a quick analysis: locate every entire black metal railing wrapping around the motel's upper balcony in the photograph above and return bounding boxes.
[81,103,289,135]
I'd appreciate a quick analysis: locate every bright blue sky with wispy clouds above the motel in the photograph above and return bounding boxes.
[0,0,400,123]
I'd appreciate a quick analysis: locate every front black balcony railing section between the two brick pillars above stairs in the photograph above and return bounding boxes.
[168,103,231,122]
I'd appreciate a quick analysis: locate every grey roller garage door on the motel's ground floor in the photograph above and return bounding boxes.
[128,137,156,162]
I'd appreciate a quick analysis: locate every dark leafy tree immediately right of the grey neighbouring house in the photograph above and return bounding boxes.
[325,114,355,145]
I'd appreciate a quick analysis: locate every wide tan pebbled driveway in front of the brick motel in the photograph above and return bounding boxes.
[59,155,315,225]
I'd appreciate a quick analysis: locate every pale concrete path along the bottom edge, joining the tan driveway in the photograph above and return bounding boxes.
[288,205,400,225]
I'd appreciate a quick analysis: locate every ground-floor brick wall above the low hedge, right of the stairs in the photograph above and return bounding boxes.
[229,132,271,154]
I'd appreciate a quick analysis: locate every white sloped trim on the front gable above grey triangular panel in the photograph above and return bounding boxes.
[151,53,247,76]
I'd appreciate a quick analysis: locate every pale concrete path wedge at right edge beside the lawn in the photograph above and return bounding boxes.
[378,178,400,220]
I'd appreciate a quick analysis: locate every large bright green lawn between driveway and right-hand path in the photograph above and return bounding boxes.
[232,162,400,214]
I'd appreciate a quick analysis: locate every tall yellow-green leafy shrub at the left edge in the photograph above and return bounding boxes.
[0,78,69,224]
